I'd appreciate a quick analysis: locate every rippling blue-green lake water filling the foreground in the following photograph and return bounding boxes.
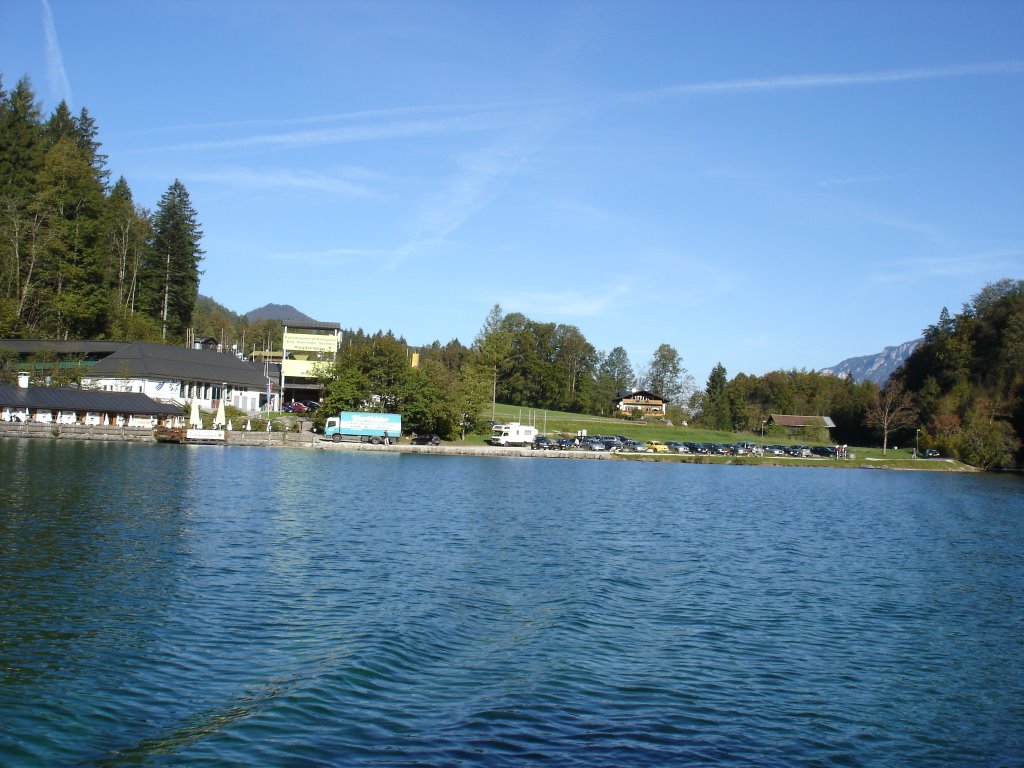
[0,439,1024,768]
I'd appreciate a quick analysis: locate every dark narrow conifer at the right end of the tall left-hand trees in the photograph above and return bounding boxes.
[144,179,204,339]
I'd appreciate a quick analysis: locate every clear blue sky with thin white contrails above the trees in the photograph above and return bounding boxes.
[0,0,1024,384]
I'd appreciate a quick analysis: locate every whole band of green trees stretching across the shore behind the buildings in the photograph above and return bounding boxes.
[6,78,1024,468]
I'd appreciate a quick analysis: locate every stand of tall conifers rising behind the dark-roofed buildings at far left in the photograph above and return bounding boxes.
[0,78,203,341]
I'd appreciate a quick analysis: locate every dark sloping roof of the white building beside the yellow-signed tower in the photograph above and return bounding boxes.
[90,341,266,388]
